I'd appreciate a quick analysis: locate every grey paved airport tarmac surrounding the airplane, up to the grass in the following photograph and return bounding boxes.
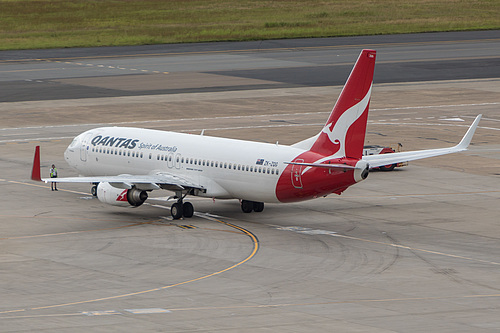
[0,32,500,332]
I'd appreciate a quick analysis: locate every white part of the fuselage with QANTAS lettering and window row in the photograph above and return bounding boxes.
[65,127,304,202]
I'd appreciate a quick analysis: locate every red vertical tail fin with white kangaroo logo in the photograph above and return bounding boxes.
[311,50,376,159]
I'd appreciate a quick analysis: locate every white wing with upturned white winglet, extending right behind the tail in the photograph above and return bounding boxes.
[363,115,482,168]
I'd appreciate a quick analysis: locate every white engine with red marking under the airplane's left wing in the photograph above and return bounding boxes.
[97,183,148,207]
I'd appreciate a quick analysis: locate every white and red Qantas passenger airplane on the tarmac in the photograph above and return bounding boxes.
[32,50,481,219]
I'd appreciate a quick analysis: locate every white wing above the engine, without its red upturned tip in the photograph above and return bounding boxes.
[42,172,203,191]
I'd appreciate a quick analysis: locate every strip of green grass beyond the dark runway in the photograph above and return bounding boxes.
[0,0,500,50]
